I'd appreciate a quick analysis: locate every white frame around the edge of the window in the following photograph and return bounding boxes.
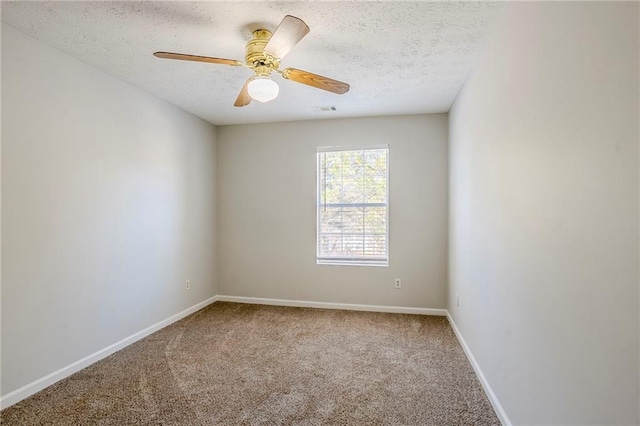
[315,144,391,267]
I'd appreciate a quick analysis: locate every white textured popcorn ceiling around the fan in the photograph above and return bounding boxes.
[2,1,499,125]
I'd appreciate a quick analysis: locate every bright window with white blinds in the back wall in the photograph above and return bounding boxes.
[317,146,389,266]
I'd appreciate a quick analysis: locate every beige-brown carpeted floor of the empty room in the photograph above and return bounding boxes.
[0,302,500,425]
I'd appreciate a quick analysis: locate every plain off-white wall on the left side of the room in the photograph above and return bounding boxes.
[2,24,217,395]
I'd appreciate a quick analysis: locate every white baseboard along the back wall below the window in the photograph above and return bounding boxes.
[217,295,447,316]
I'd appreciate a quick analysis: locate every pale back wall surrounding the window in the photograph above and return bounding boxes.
[217,114,448,308]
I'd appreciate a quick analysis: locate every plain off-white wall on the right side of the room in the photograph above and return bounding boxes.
[449,2,640,425]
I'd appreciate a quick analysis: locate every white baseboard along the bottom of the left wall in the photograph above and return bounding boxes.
[0,296,218,409]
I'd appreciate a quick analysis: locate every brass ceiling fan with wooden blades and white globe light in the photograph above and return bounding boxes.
[154,15,349,107]
